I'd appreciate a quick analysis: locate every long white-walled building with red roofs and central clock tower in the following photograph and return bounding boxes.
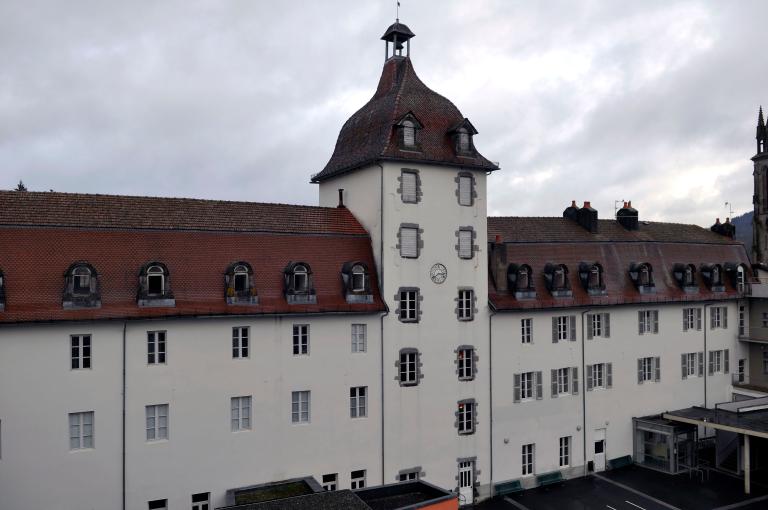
[0,17,750,510]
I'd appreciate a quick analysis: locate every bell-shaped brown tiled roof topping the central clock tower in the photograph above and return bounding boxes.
[312,57,498,182]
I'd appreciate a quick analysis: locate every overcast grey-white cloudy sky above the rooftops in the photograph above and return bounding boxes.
[0,0,768,226]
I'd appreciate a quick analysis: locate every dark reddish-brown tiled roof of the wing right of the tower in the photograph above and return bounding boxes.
[488,217,749,310]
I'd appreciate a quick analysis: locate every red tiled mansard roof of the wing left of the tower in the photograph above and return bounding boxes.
[0,192,385,323]
